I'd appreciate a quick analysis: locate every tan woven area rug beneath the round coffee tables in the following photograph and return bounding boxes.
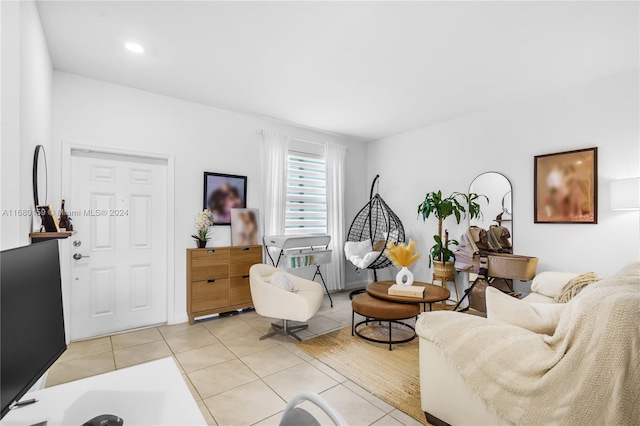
[297,326,427,424]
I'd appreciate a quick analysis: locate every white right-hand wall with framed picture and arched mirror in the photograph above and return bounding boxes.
[367,69,640,292]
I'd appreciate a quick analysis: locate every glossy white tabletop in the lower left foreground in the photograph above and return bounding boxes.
[2,358,207,426]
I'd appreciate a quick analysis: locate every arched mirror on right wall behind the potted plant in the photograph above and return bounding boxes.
[469,172,513,246]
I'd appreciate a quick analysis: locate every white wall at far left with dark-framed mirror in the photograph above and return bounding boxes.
[0,1,54,249]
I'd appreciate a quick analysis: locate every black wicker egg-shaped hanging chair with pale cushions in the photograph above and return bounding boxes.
[347,175,405,281]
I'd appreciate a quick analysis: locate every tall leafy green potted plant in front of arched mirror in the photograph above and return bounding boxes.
[418,191,489,276]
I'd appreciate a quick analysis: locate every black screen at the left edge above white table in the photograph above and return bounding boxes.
[0,240,67,418]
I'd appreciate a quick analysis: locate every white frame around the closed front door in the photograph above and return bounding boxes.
[60,141,176,336]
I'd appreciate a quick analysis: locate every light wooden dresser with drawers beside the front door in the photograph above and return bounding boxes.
[187,246,262,324]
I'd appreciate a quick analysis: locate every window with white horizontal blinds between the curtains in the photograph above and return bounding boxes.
[284,151,327,235]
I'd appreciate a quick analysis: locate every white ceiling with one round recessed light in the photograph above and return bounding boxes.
[38,1,639,140]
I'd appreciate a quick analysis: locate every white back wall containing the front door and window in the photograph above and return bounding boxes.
[53,71,368,321]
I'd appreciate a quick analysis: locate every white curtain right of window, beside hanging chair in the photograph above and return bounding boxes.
[325,143,347,290]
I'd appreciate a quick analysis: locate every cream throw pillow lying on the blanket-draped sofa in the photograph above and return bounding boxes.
[486,287,567,336]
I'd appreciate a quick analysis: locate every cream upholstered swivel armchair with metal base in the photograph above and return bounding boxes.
[249,263,324,340]
